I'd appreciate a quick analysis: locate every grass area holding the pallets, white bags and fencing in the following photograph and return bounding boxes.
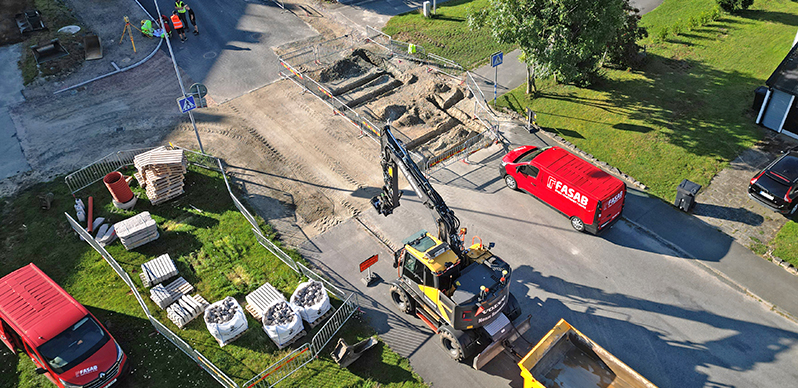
[0,167,424,388]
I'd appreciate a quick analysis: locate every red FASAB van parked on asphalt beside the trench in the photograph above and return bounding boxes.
[500,146,626,234]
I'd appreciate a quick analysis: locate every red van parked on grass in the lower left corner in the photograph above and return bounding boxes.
[0,263,128,388]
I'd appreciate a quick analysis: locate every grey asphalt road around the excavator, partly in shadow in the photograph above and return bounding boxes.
[303,142,798,388]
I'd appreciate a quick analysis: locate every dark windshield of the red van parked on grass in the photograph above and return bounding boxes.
[39,315,109,374]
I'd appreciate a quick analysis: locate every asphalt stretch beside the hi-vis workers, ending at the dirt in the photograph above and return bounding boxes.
[142,0,317,103]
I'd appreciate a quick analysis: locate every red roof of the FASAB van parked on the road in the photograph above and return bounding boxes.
[534,147,624,200]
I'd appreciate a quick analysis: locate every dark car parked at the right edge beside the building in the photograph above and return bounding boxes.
[748,148,798,214]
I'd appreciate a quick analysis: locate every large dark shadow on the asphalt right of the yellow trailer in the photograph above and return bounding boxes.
[512,265,798,387]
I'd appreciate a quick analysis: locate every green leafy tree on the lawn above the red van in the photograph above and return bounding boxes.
[468,0,628,90]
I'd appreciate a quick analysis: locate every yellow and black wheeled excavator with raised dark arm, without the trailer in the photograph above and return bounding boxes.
[371,126,521,368]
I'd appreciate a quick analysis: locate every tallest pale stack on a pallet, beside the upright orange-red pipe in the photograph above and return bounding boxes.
[133,147,188,205]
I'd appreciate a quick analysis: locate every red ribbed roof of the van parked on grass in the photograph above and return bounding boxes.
[0,263,89,347]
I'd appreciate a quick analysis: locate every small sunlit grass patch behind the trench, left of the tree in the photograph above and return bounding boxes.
[382,0,514,68]
